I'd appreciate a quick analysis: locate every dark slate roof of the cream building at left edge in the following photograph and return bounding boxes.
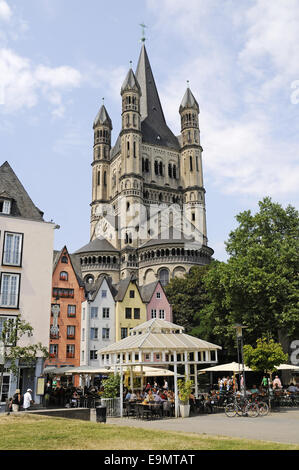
[0,162,44,221]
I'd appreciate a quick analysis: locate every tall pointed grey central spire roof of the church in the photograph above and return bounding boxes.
[136,44,180,149]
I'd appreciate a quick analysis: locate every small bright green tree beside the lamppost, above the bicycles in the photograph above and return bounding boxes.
[243,337,288,373]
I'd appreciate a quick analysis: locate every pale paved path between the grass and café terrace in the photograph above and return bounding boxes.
[107,409,299,444]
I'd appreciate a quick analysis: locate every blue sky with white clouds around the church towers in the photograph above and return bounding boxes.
[0,0,299,260]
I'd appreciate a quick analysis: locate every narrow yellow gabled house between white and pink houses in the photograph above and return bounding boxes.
[115,277,147,341]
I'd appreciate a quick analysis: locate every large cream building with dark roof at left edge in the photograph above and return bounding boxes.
[0,162,55,403]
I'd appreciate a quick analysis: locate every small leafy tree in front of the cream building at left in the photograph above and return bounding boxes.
[0,315,49,396]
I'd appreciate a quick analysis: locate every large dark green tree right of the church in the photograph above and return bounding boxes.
[204,198,299,350]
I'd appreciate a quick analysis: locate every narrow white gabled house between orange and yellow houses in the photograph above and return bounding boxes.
[80,276,116,366]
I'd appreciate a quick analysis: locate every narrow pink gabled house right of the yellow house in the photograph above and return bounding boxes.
[141,281,172,322]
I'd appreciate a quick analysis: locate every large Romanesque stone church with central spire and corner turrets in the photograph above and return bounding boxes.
[75,41,213,286]
